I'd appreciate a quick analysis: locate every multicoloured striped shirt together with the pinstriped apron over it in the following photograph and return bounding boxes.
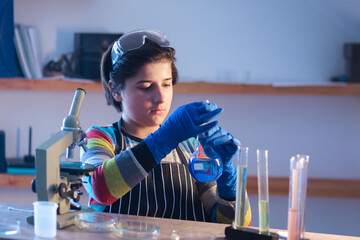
[81,121,251,225]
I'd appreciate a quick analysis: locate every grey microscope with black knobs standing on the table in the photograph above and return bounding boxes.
[27,88,96,228]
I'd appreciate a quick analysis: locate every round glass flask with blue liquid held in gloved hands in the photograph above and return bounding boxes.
[189,135,223,182]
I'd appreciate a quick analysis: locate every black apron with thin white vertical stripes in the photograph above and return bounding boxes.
[104,122,211,222]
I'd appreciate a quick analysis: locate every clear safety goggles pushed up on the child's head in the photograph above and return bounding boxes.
[111,30,170,65]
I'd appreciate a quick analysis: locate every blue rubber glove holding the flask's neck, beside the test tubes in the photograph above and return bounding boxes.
[199,127,240,199]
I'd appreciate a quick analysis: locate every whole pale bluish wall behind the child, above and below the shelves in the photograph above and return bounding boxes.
[0,0,360,236]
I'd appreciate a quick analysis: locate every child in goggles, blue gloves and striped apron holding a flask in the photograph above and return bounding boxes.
[81,30,251,225]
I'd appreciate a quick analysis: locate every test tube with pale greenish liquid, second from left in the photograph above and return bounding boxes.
[256,149,269,234]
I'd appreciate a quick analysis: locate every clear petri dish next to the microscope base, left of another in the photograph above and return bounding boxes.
[74,212,118,232]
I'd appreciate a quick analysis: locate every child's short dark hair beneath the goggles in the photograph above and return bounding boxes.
[100,39,178,112]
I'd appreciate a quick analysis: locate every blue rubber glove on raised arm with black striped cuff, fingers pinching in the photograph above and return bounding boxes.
[144,102,222,163]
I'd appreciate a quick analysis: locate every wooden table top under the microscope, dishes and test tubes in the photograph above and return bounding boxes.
[0,203,360,240]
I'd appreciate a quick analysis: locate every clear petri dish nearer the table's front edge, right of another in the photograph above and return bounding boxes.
[114,221,160,239]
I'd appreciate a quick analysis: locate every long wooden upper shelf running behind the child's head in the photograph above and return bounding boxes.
[0,78,360,96]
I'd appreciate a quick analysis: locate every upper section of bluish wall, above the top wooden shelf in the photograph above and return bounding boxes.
[14,0,360,83]
